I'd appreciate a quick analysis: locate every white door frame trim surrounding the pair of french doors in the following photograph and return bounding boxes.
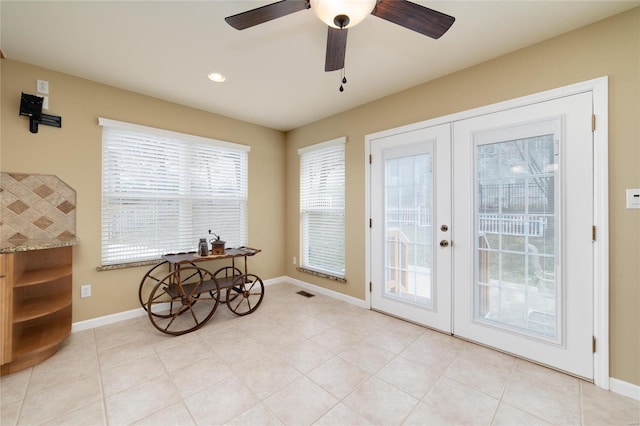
[364,76,609,390]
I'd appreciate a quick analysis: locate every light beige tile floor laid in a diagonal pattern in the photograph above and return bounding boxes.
[0,283,640,426]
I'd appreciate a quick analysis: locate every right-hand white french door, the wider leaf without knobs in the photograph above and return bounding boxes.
[453,93,594,379]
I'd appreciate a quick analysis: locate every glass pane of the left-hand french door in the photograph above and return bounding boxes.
[384,153,434,308]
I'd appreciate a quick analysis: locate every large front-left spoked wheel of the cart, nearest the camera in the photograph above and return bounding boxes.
[147,267,220,336]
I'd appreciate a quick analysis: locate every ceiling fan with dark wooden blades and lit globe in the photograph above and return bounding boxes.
[225,0,455,71]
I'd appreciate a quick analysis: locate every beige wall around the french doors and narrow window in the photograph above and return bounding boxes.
[286,8,640,385]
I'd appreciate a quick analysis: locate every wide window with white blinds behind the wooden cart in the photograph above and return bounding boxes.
[99,118,249,266]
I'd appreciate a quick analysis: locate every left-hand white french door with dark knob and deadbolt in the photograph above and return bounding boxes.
[370,124,451,332]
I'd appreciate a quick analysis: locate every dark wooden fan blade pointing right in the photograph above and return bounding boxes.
[371,0,456,39]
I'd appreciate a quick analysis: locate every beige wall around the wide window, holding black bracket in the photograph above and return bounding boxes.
[0,59,285,322]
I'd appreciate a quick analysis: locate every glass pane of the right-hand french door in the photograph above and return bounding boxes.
[474,135,561,339]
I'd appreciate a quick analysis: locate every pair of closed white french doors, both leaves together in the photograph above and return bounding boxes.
[370,92,594,379]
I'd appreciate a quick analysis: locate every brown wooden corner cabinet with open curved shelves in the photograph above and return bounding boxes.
[0,247,72,375]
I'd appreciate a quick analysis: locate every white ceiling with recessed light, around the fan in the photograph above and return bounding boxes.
[0,0,640,131]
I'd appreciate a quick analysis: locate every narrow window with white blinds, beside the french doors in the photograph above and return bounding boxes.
[298,138,346,278]
